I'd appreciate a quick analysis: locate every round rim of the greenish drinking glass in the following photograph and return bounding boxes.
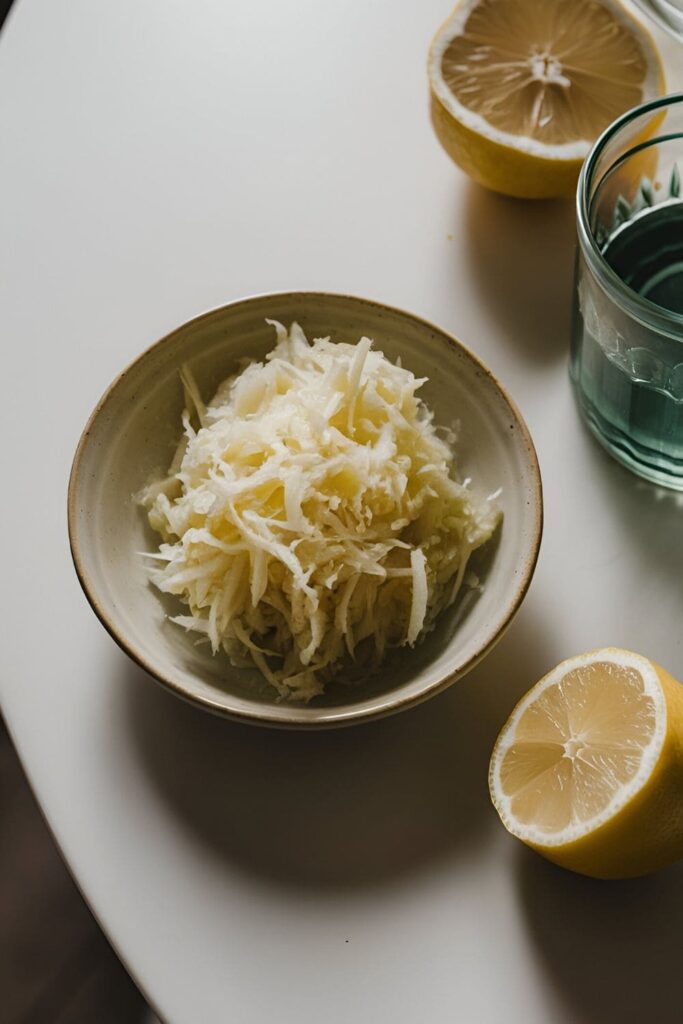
[577,92,683,340]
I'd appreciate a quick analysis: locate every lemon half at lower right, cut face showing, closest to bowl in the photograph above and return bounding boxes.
[489,648,683,879]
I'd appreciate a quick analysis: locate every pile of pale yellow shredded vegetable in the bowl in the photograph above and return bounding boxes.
[141,321,500,701]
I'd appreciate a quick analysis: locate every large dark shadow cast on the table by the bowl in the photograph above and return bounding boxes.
[122,598,554,891]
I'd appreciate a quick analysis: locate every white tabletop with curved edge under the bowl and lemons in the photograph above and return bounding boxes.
[0,0,683,1024]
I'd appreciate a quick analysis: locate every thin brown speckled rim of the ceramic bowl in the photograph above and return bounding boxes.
[67,291,543,729]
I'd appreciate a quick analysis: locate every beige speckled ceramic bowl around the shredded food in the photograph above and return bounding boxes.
[69,292,543,727]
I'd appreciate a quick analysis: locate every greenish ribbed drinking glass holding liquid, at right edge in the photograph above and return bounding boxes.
[570,94,683,490]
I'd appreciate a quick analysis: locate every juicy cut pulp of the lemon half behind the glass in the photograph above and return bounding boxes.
[441,0,648,145]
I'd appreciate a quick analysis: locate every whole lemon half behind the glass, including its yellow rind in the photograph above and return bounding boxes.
[428,0,665,198]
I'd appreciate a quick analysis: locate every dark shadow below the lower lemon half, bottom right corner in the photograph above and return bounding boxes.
[515,846,683,1024]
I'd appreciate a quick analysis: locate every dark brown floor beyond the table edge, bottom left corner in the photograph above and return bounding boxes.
[0,719,148,1024]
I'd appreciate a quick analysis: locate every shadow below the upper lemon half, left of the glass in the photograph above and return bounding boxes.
[459,183,575,364]
